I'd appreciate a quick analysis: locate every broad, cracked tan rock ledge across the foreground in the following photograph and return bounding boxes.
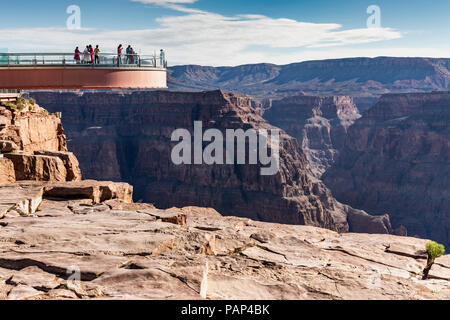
[0,181,450,300]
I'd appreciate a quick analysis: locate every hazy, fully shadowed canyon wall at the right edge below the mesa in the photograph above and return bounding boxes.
[324,92,450,244]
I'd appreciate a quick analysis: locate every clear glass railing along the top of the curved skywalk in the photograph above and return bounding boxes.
[0,53,167,69]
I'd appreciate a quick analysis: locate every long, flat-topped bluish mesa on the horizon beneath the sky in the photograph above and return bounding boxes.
[168,57,450,113]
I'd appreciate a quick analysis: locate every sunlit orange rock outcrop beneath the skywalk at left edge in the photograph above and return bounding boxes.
[0,98,81,183]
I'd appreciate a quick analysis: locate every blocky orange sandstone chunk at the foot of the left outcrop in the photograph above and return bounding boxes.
[4,153,67,181]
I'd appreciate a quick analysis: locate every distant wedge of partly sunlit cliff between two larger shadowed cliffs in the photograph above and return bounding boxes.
[263,96,361,178]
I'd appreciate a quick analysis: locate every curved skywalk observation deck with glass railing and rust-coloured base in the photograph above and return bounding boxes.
[0,53,167,90]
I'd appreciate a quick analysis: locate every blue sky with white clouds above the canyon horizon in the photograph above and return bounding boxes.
[0,0,450,66]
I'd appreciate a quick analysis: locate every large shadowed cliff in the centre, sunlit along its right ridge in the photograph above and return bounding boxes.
[33,91,390,233]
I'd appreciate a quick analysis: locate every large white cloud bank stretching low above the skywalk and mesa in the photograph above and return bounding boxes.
[0,0,422,65]
